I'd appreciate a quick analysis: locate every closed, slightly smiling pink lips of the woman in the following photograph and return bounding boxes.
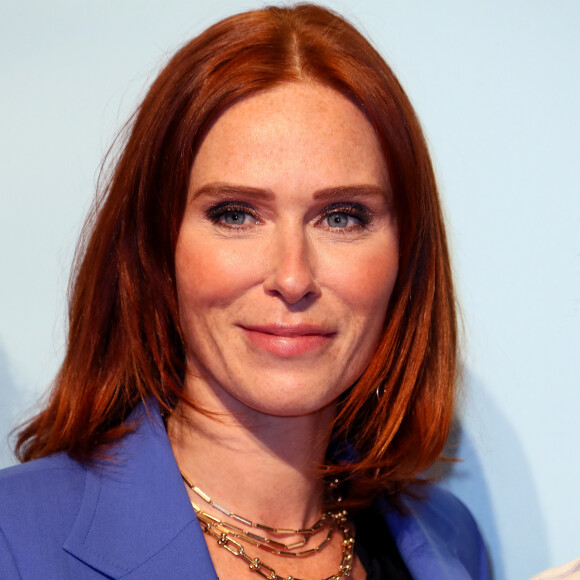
[241,324,336,358]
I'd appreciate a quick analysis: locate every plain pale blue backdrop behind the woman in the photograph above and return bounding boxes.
[0,0,580,580]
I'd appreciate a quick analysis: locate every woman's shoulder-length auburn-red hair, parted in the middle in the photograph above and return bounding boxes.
[16,5,456,501]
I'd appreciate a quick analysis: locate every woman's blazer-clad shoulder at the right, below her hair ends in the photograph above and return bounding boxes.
[384,486,490,580]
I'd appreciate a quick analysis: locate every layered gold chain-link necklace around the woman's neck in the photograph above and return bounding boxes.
[181,473,354,580]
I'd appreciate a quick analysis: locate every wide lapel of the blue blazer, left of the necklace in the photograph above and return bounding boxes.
[64,403,217,580]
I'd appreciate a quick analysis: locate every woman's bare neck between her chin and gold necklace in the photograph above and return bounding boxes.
[168,390,335,529]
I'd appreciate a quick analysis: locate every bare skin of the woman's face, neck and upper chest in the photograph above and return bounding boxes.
[169,84,398,578]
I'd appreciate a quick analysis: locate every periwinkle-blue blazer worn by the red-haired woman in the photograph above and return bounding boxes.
[0,406,489,580]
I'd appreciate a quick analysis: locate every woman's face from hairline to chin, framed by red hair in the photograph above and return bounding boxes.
[175,84,398,416]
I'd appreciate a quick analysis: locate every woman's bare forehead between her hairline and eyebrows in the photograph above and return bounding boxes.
[191,83,387,193]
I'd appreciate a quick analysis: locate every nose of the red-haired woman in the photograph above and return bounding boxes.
[264,227,320,305]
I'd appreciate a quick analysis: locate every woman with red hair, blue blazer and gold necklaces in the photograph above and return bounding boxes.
[0,5,488,580]
